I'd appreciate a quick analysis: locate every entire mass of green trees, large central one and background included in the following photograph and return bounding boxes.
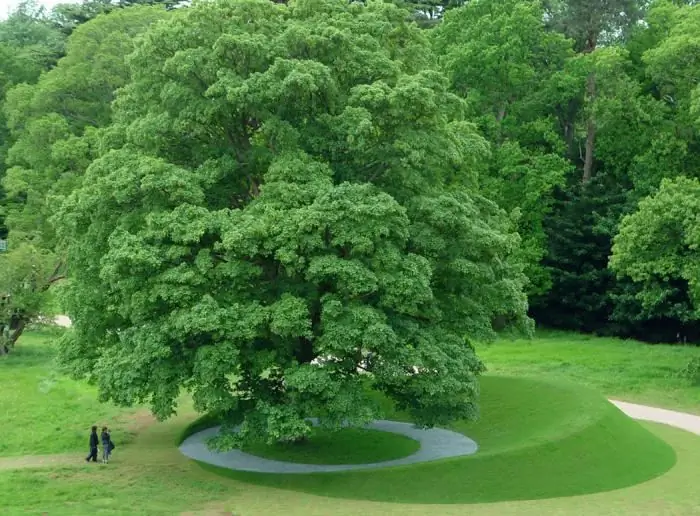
[0,0,700,438]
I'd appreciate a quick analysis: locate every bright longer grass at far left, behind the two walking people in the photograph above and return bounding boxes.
[0,330,144,456]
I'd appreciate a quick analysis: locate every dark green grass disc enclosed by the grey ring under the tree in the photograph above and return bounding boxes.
[243,428,420,464]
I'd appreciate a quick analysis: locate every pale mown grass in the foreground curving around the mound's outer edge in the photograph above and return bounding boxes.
[0,420,700,516]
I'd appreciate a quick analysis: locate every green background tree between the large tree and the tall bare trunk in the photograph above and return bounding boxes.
[433,0,572,293]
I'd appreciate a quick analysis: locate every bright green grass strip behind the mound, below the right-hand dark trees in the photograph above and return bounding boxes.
[477,331,700,414]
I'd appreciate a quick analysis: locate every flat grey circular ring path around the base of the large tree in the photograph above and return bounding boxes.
[180,420,478,473]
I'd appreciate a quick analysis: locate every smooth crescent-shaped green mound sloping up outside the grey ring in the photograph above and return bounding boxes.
[189,376,676,504]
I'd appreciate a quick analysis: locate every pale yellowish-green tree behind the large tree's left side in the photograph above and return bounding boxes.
[0,8,165,348]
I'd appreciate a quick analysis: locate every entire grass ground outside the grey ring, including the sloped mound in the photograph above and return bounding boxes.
[0,328,700,516]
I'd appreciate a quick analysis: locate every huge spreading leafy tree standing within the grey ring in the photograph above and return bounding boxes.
[59,0,529,445]
